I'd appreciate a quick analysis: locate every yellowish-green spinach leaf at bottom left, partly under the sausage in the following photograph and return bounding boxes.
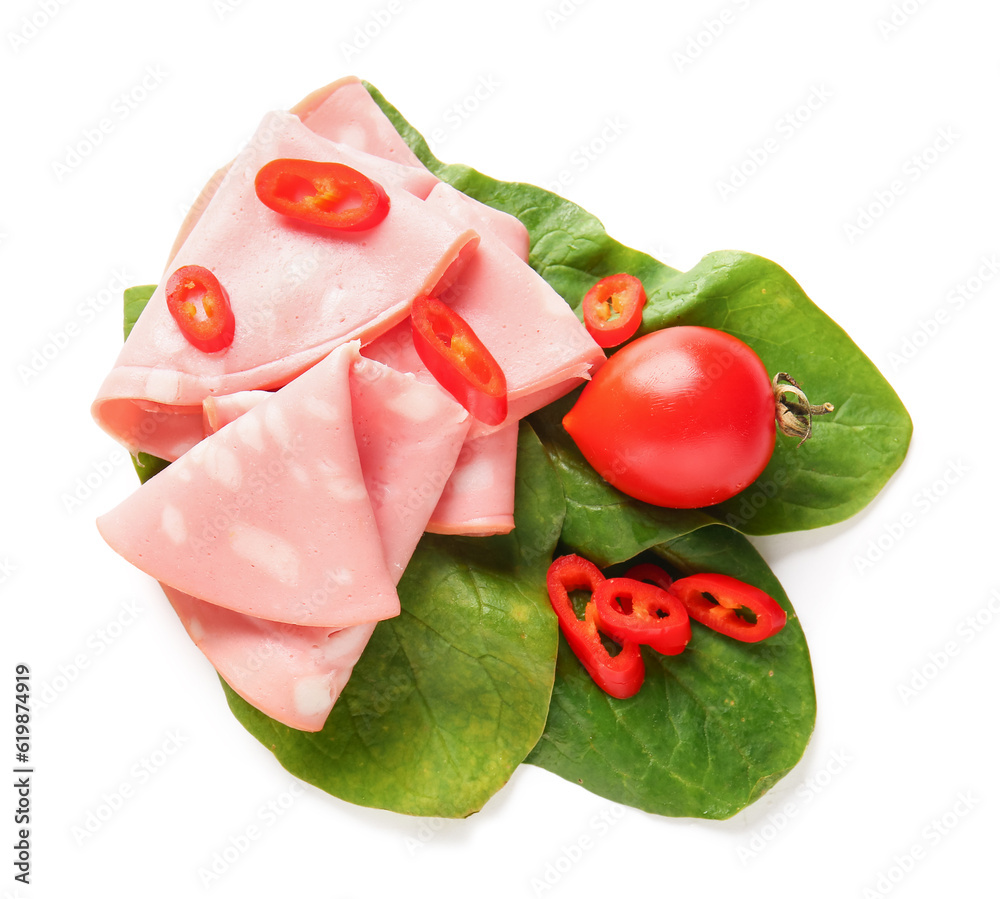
[226,424,563,817]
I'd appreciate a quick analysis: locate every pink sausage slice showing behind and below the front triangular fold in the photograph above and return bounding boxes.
[163,348,469,731]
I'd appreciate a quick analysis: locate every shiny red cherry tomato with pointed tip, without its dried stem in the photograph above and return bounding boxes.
[563,326,775,509]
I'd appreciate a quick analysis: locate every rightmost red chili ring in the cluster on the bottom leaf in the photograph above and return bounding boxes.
[670,574,785,643]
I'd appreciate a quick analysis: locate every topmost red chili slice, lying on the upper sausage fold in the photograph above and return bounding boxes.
[254,159,389,231]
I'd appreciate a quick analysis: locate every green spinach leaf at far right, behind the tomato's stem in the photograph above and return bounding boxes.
[643,252,912,534]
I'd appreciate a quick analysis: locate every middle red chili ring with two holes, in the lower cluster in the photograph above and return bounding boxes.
[594,577,691,656]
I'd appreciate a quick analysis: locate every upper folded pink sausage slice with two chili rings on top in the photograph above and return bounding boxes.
[93,112,479,461]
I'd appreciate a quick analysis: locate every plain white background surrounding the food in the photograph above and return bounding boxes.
[0,0,1000,899]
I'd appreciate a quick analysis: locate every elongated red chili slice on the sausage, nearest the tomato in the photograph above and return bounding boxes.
[410,296,507,425]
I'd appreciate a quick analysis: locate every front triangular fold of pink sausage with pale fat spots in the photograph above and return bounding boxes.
[98,344,465,628]
